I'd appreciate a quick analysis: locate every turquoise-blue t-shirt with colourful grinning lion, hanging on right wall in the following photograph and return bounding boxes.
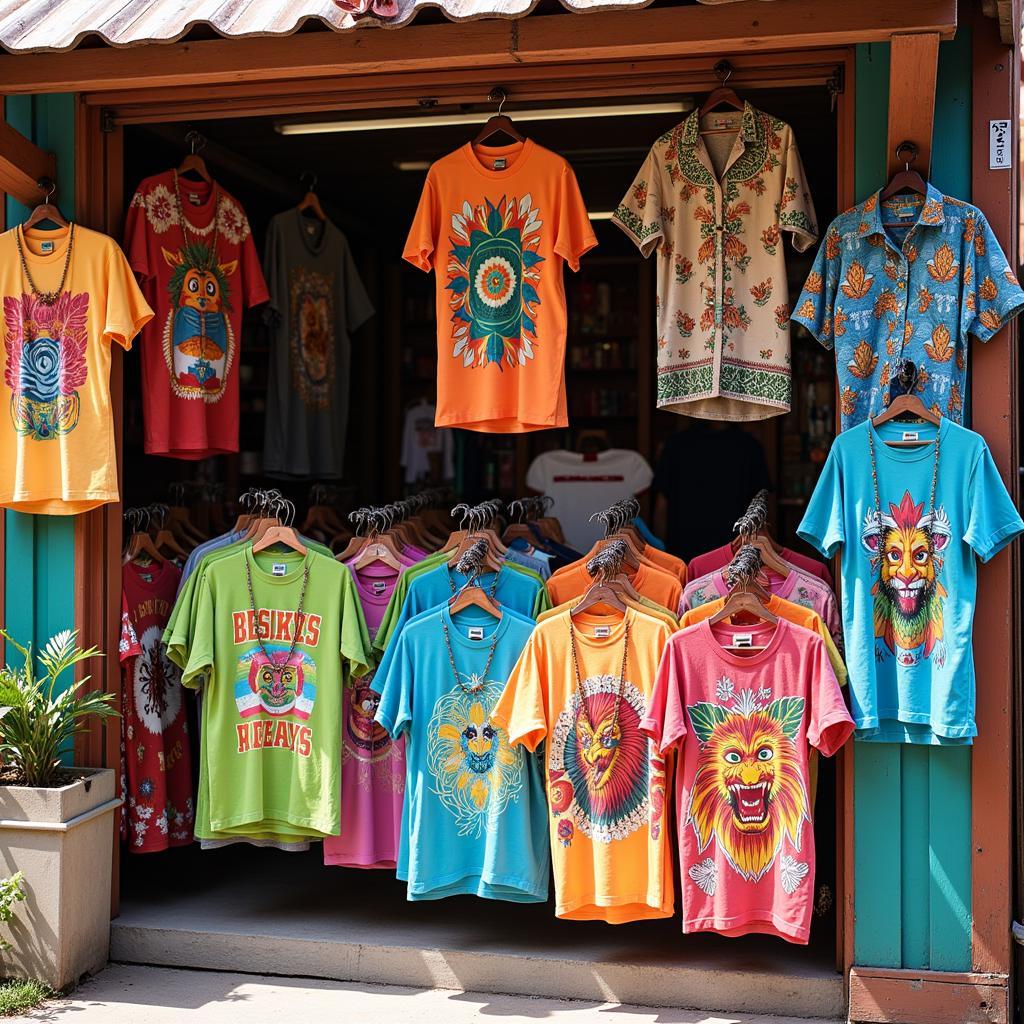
[798,419,1024,743]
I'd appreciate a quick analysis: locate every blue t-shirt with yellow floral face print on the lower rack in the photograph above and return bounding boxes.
[374,606,551,903]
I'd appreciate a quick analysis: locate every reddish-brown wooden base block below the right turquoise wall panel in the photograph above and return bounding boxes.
[848,967,1010,1024]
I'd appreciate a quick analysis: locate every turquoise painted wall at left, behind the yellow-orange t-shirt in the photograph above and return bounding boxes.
[3,95,75,663]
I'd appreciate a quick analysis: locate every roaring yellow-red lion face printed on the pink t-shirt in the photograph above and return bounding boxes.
[688,691,810,882]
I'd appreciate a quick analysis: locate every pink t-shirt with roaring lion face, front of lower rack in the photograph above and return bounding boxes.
[641,620,853,943]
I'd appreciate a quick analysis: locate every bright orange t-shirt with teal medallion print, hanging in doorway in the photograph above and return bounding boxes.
[402,139,597,433]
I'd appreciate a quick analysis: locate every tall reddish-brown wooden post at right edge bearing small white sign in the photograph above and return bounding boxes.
[971,5,1021,973]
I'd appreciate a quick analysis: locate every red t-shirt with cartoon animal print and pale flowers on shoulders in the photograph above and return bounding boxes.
[125,170,268,459]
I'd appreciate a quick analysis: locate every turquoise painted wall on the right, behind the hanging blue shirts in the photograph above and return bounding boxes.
[854,36,971,971]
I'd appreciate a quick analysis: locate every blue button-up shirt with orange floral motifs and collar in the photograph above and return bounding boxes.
[793,185,1024,430]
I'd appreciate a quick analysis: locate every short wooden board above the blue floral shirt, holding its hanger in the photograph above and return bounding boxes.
[886,32,939,179]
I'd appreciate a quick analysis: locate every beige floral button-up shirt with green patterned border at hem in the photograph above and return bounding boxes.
[612,103,818,420]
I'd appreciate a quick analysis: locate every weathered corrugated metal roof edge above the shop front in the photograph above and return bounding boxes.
[0,0,761,53]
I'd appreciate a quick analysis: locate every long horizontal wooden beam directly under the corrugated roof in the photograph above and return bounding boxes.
[0,0,956,94]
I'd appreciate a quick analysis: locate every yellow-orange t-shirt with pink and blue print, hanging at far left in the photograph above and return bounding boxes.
[0,224,153,515]
